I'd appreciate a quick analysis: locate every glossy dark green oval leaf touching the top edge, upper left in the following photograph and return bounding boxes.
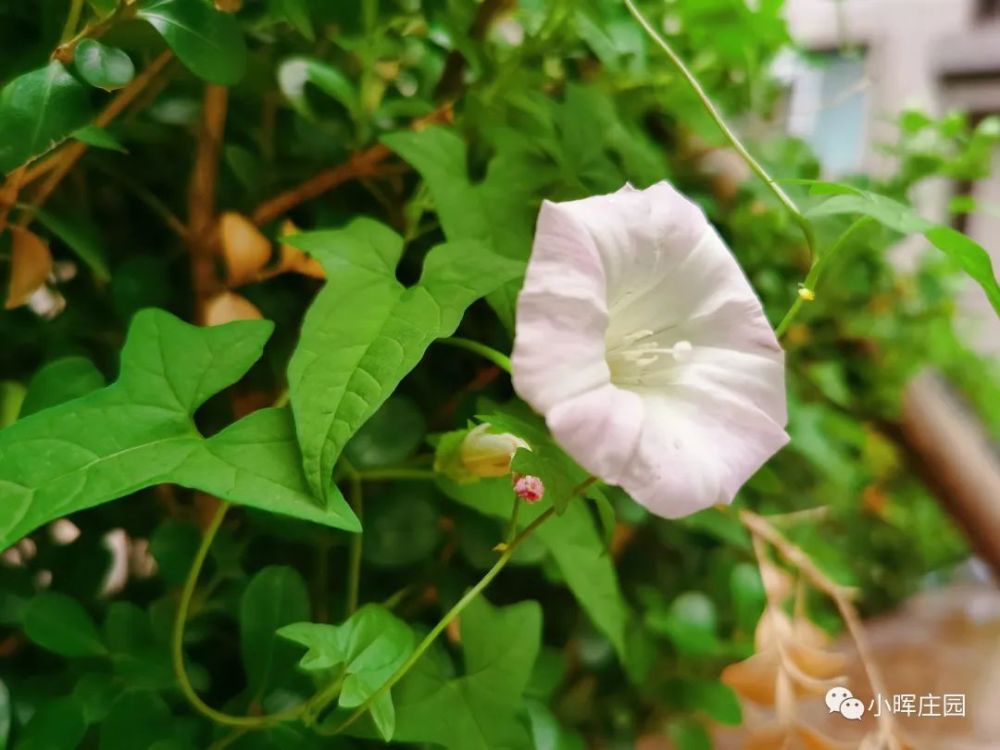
[136,0,247,86]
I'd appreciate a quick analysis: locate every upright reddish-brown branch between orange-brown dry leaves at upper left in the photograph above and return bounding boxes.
[187,84,229,323]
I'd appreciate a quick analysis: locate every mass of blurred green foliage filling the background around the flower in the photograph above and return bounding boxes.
[0,0,1000,750]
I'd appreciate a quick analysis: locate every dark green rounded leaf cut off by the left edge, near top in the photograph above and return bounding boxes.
[0,60,92,174]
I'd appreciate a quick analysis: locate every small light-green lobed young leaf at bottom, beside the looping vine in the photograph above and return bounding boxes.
[278,604,416,742]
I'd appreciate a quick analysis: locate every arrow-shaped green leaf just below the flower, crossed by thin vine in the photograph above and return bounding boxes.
[438,478,629,662]
